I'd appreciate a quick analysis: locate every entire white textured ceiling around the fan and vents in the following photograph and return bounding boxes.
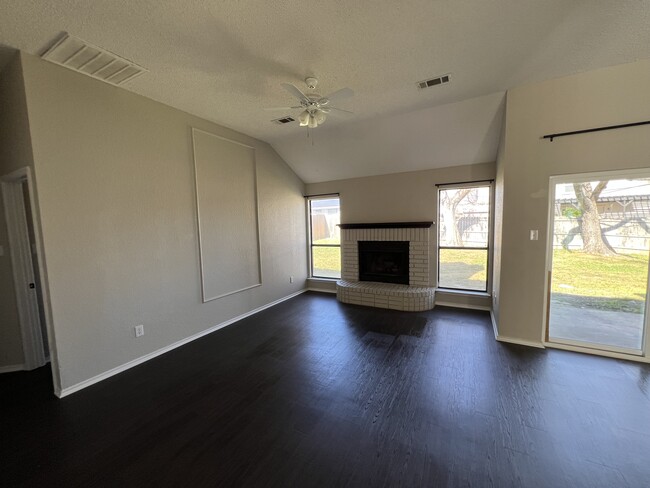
[0,0,650,182]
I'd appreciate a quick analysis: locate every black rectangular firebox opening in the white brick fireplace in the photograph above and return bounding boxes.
[359,241,409,285]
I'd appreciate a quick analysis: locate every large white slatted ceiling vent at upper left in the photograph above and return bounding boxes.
[42,33,147,85]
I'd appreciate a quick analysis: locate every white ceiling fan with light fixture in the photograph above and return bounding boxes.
[265,77,354,129]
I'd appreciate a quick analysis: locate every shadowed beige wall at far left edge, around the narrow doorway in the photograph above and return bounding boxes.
[0,55,33,368]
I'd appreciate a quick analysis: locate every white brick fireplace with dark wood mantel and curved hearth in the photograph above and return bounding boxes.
[336,222,435,311]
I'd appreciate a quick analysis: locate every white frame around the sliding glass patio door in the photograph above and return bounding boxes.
[542,168,650,363]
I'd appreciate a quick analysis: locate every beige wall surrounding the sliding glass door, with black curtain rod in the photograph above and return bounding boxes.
[498,61,650,344]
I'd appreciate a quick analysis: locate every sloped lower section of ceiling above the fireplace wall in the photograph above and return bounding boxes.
[275,92,505,182]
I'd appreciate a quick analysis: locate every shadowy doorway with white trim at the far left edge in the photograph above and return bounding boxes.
[2,168,51,370]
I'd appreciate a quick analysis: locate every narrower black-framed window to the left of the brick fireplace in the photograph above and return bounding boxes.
[307,195,341,278]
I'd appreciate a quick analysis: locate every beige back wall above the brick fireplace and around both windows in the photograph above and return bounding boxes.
[307,163,495,307]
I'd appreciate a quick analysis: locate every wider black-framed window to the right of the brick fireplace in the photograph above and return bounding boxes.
[438,183,492,292]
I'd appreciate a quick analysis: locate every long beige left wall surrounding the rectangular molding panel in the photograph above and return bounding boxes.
[17,55,307,389]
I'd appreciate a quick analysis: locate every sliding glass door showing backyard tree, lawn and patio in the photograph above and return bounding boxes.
[546,171,650,356]
